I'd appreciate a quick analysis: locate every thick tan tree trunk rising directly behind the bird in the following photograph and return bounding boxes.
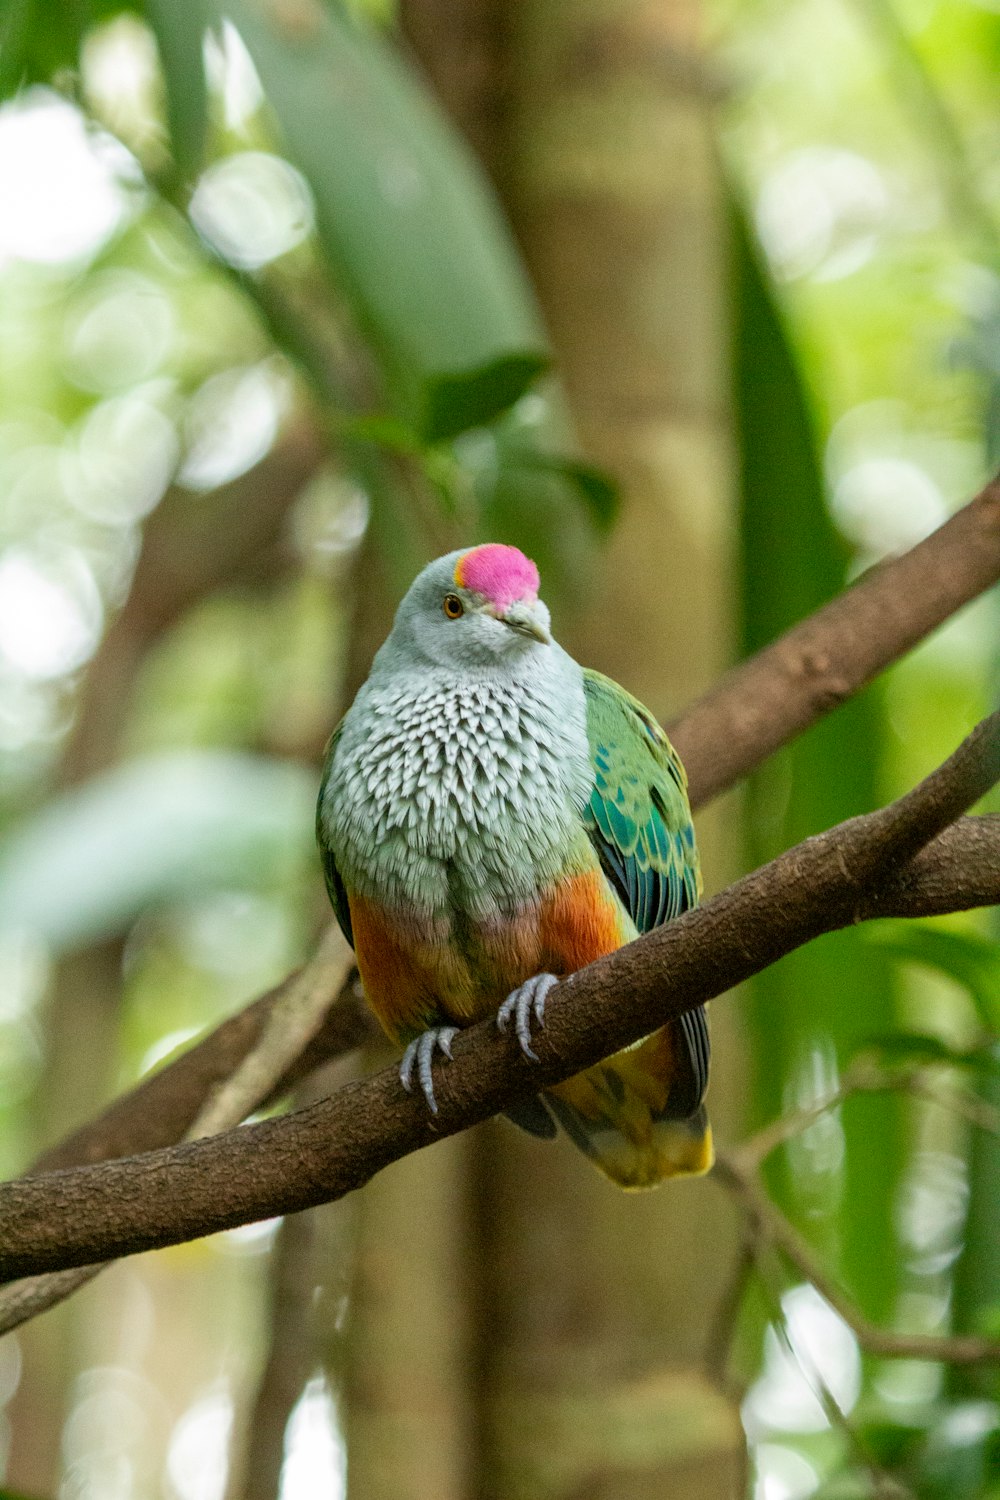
[406,0,744,1500]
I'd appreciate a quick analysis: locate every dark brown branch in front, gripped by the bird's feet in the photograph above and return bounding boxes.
[0,714,1000,1278]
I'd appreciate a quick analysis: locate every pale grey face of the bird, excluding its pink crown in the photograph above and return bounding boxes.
[379,551,552,669]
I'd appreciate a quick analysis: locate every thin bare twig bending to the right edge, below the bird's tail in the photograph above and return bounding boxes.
[712,1152,1000,1365]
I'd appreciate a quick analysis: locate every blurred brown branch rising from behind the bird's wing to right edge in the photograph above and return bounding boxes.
[670,480,1000,807]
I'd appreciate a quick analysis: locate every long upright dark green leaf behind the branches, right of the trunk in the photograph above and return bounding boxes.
[732,187,904,1317]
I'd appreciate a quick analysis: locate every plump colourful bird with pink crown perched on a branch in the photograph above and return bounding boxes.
[316,542,712,1188]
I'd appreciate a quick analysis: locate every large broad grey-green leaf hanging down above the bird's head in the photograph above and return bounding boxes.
[213,0,549,441]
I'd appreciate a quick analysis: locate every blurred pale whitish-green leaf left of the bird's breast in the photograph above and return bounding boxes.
[0,750,316,950]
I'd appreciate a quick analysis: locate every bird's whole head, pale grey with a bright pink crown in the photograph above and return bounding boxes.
[387,542,552,669]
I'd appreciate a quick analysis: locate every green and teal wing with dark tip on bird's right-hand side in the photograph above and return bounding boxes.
[583,669,709,1118]
